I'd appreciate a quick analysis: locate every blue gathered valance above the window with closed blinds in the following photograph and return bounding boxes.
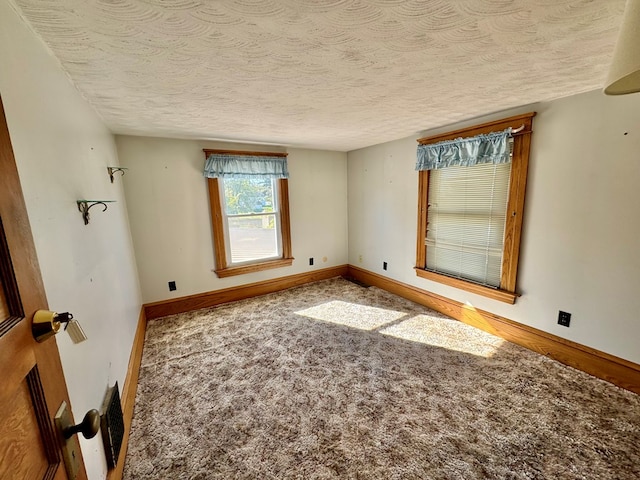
[416,128,511,170]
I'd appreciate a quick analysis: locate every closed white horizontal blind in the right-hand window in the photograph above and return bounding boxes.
[426,162,511,287]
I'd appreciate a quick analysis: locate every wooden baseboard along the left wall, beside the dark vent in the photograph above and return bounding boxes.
[107,306,147,480]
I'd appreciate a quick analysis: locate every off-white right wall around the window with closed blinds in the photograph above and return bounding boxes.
[348,91,640,363]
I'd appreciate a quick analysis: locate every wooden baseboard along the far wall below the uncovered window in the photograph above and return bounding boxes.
[144,265,348,320]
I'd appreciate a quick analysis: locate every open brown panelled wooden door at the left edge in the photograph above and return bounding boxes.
[0,94,87,480]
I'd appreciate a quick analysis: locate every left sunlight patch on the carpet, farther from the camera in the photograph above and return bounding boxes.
[295,300,407,330]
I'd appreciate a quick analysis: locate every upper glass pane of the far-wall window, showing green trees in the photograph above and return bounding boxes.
[223,177,276,215]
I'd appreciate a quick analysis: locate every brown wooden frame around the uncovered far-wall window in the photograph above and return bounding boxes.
[203,149,294,278]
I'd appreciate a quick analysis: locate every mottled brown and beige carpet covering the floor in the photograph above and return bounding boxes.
[124,279,640,479]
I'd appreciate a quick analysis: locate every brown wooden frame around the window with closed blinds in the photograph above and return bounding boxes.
[415,112,536,304]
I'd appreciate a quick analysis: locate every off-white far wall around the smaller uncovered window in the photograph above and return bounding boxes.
[116,136,347,302]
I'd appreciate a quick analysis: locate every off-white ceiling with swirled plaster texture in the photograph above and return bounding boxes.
[10,0,625,151]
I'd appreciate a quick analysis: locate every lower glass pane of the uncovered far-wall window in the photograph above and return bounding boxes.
[227,214,280,263]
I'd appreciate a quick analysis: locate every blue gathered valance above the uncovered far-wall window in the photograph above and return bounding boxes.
[204,153,289,178]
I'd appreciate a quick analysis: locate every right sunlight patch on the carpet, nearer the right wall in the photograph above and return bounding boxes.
[380,315,504,358]
